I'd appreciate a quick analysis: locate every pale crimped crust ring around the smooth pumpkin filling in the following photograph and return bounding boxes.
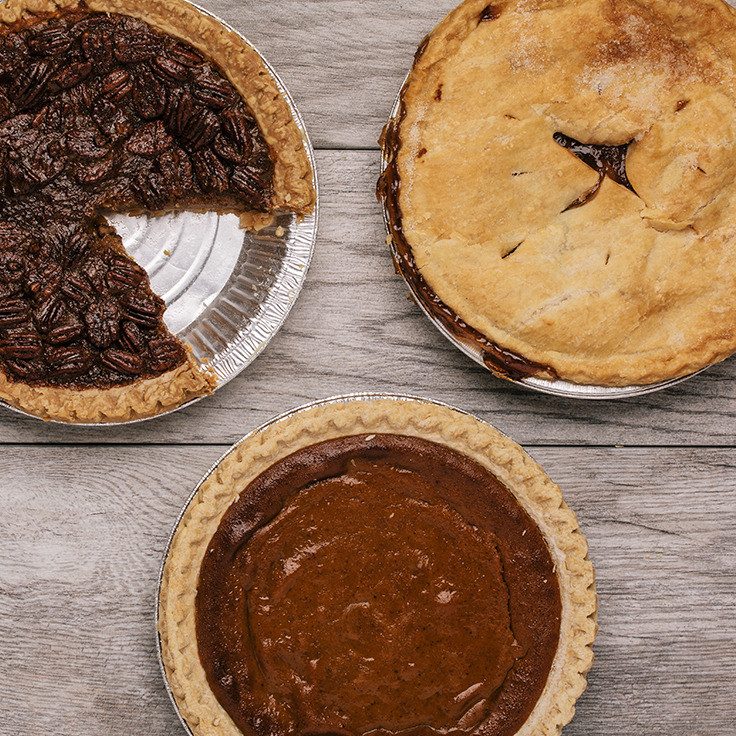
[158,397,597,736]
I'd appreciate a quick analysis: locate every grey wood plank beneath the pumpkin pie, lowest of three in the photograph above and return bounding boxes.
[0,446,736,736]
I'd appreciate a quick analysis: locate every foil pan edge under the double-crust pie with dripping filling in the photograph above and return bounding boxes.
[380,80,710,400]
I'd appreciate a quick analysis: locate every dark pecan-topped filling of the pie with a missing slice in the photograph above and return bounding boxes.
[0,5,273,389]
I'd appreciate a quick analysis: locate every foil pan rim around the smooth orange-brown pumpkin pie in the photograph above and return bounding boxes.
[154,392,508,736]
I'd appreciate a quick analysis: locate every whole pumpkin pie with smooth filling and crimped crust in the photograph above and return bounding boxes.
[159,397,597,736]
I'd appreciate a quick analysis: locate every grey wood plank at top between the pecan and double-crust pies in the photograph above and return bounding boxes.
[202,0,457,148]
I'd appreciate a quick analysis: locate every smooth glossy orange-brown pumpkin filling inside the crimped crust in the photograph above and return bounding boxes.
[196,434,561,736]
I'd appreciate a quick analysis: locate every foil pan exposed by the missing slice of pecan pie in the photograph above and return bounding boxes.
[0,3,319,427]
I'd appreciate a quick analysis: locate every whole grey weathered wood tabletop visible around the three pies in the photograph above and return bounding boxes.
[0,0,736,736]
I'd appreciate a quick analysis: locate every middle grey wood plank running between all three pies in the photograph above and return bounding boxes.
[0,151,736,445]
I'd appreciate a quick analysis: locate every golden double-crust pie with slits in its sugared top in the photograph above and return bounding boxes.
[379,0,736,386]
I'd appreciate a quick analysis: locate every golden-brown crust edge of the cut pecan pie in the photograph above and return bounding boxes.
[0,0,316,422]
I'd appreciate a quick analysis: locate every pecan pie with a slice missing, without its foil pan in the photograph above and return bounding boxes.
[0,0,315,421]
